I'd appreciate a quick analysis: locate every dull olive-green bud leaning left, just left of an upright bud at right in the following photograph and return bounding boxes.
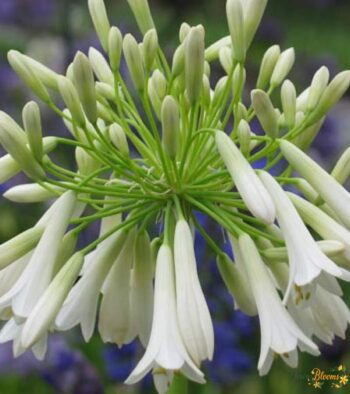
[251,89,278,138]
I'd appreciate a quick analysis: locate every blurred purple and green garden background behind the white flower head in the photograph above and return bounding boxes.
[0,0,350,394]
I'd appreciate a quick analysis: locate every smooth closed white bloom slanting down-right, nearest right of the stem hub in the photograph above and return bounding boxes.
[215,131,275,224]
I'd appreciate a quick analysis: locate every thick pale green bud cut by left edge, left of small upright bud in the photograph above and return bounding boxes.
[0,112,45,180]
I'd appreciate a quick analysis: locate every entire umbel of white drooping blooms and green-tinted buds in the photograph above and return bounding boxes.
[0,0,350,393]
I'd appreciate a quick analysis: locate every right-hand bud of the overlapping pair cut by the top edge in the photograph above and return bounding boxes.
[244,0,267,49]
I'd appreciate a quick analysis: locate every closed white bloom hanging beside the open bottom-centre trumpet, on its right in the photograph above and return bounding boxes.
[174,219,214,364]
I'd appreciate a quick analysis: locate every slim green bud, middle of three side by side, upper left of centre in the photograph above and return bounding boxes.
[123,34,145,92]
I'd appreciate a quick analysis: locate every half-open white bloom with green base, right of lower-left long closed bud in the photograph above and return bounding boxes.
[56,231,126,341]
